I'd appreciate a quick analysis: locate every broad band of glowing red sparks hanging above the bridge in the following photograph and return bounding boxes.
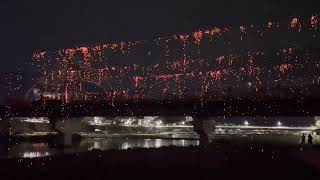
[32,15,320,102]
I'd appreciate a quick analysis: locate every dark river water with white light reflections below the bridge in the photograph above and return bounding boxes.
[0,138,199,158]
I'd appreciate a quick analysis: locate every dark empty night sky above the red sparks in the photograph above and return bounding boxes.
[0,0,320,72]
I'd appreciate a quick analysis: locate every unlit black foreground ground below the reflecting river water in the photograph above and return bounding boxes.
[0,144,320,180]
